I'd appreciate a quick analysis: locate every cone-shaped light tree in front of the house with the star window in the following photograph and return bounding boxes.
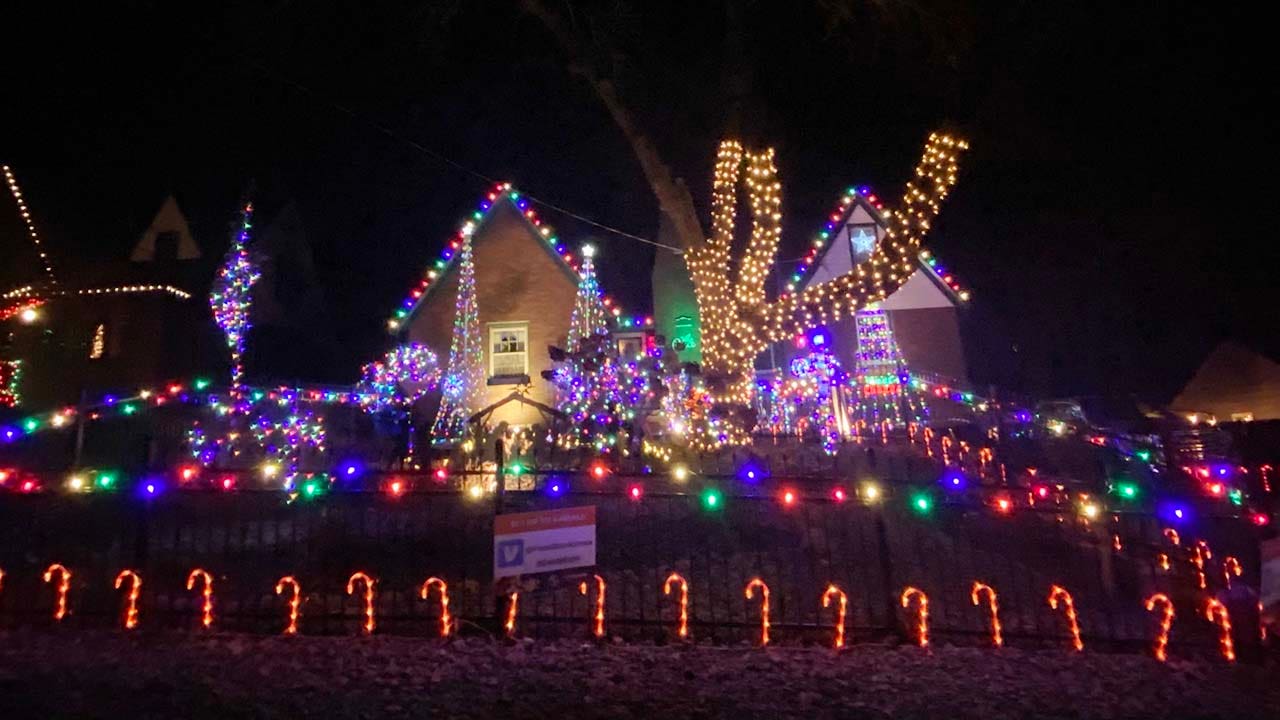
[852,305,924,425]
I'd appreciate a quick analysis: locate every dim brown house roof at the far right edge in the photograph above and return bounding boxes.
[1169,342,1280,420]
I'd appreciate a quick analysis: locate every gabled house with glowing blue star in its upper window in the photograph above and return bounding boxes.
[758,187,969,386]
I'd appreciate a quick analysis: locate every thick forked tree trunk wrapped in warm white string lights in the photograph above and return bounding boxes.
[685,133,968,447]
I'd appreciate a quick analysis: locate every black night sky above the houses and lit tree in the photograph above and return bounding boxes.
[0,0,1280,400]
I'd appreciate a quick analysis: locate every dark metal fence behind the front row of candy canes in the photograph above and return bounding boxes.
[0,475,1257,652]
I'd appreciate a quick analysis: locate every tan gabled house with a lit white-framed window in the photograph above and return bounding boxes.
[393,187,579,424]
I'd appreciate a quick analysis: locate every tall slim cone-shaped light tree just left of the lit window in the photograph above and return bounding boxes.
[431,234,484,445]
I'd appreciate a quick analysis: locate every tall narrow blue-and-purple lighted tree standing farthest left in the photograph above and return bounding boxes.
[209,196,261,405]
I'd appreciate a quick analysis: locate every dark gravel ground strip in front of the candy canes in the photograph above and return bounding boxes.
[0,632,1280,720]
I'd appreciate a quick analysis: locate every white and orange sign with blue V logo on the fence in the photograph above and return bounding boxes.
[493,505,595,580]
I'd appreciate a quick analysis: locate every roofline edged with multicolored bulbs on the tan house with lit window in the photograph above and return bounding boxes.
[387,182,653,333]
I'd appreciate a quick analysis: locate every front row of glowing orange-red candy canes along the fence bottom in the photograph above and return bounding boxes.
[0,562,1249,662]
